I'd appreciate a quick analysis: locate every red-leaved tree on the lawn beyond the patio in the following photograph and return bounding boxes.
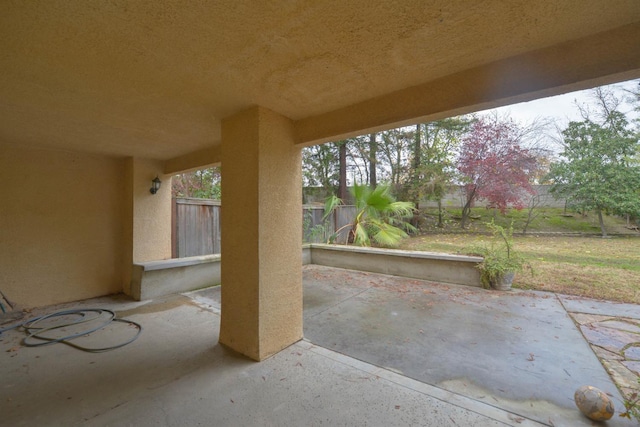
[457,117,537,228]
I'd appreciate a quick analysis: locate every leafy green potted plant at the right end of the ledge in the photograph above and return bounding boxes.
[471,221,526,291]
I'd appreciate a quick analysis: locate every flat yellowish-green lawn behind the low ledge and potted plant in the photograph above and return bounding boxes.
[400,234,640,304]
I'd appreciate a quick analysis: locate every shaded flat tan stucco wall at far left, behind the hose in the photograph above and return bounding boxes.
[0,144,124,307]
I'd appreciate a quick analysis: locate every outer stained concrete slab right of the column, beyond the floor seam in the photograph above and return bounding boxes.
[304,266,640,426]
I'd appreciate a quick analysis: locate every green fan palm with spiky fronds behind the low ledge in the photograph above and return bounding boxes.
[325,185,416,247]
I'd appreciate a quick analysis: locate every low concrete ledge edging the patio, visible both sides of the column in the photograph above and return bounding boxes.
[131,243,482,300]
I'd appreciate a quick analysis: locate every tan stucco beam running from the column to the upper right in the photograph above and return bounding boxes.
[295,23,640,146]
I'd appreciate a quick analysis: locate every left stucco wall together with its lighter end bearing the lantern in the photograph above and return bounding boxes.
[0,144,171,307]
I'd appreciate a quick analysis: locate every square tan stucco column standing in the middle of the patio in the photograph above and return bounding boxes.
[220,107,302,360]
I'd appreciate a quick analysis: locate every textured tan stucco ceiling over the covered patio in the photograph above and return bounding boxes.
[0,0,640,166]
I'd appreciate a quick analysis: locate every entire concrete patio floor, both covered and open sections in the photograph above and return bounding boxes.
[0,266,640,426]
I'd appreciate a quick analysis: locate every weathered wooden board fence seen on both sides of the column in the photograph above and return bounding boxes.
[171,199,355,258]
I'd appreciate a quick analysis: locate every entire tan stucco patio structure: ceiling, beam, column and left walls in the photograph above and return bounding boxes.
[0,0,640,338]
